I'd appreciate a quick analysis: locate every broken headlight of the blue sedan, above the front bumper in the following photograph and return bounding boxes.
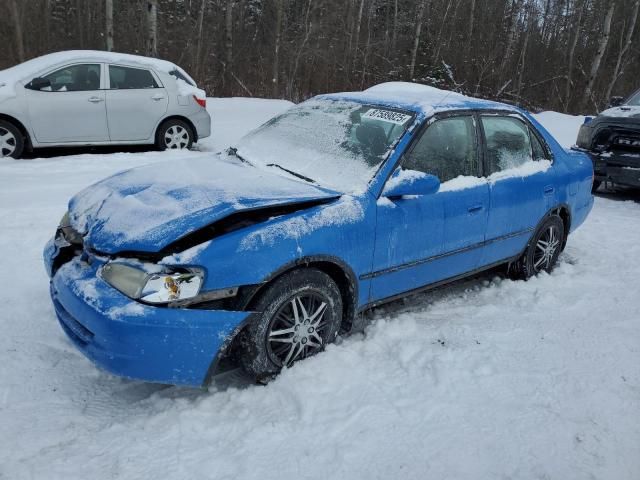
[100,263,204,304]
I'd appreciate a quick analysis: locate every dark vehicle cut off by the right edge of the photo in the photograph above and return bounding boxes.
[576,90,640,191]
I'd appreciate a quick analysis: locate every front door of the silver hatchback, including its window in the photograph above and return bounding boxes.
[24,63,109,144]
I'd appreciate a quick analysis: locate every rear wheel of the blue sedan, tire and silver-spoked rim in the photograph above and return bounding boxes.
[509,215,565,280]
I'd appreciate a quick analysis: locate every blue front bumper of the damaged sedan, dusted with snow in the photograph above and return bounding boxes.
[45,249,250,386]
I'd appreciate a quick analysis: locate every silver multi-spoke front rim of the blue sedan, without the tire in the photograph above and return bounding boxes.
[267,292,328,367]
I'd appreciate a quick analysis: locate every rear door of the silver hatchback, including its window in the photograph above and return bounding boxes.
[106,65,169,142]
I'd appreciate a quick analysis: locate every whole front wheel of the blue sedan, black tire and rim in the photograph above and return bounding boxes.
[239,268,343,382]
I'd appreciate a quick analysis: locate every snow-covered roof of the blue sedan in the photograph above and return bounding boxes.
[318,82,522,116]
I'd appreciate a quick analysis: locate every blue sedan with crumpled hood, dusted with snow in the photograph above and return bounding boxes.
[44,83,593,386]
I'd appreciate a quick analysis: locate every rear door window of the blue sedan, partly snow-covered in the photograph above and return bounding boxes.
[482,116,544,175]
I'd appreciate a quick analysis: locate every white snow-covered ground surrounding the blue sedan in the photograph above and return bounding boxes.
[0,99,640,480]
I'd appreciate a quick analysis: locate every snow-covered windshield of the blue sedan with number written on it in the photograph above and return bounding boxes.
[235,99,413,193]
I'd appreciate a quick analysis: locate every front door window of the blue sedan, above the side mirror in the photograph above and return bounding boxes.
[402,115,479,183]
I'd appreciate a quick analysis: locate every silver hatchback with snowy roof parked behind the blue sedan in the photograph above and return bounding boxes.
[0,50,211,158]
